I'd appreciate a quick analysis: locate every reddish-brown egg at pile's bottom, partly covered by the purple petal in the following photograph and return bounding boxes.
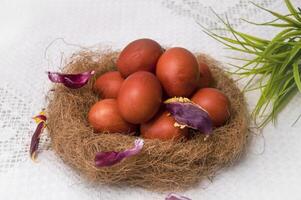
[140,111,188,140]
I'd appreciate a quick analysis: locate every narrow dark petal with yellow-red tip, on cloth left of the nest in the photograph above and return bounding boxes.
[29,111,47,160]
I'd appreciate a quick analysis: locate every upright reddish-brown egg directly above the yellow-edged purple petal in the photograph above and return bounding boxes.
[156,47,200,97]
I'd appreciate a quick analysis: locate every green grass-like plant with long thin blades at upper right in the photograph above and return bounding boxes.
[202,0,301,127]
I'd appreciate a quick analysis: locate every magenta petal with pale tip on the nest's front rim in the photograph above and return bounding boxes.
[95,139,144,167]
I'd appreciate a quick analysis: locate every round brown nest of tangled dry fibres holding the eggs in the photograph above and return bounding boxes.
[47,51,248,191]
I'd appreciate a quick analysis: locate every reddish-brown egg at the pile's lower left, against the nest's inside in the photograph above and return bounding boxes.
[88,99,136,134]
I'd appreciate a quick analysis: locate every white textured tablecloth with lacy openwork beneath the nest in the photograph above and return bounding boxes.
[0,0,301,200]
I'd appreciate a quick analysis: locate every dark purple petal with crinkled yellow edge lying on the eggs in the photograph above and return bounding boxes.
[165,97,212,134]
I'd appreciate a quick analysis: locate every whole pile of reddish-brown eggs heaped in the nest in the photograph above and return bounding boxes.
[88,39,230,140]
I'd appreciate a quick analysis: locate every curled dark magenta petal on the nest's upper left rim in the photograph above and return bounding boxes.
[47,71,95,89]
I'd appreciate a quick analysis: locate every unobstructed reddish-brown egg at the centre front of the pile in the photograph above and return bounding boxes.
[117,71,162,124]
